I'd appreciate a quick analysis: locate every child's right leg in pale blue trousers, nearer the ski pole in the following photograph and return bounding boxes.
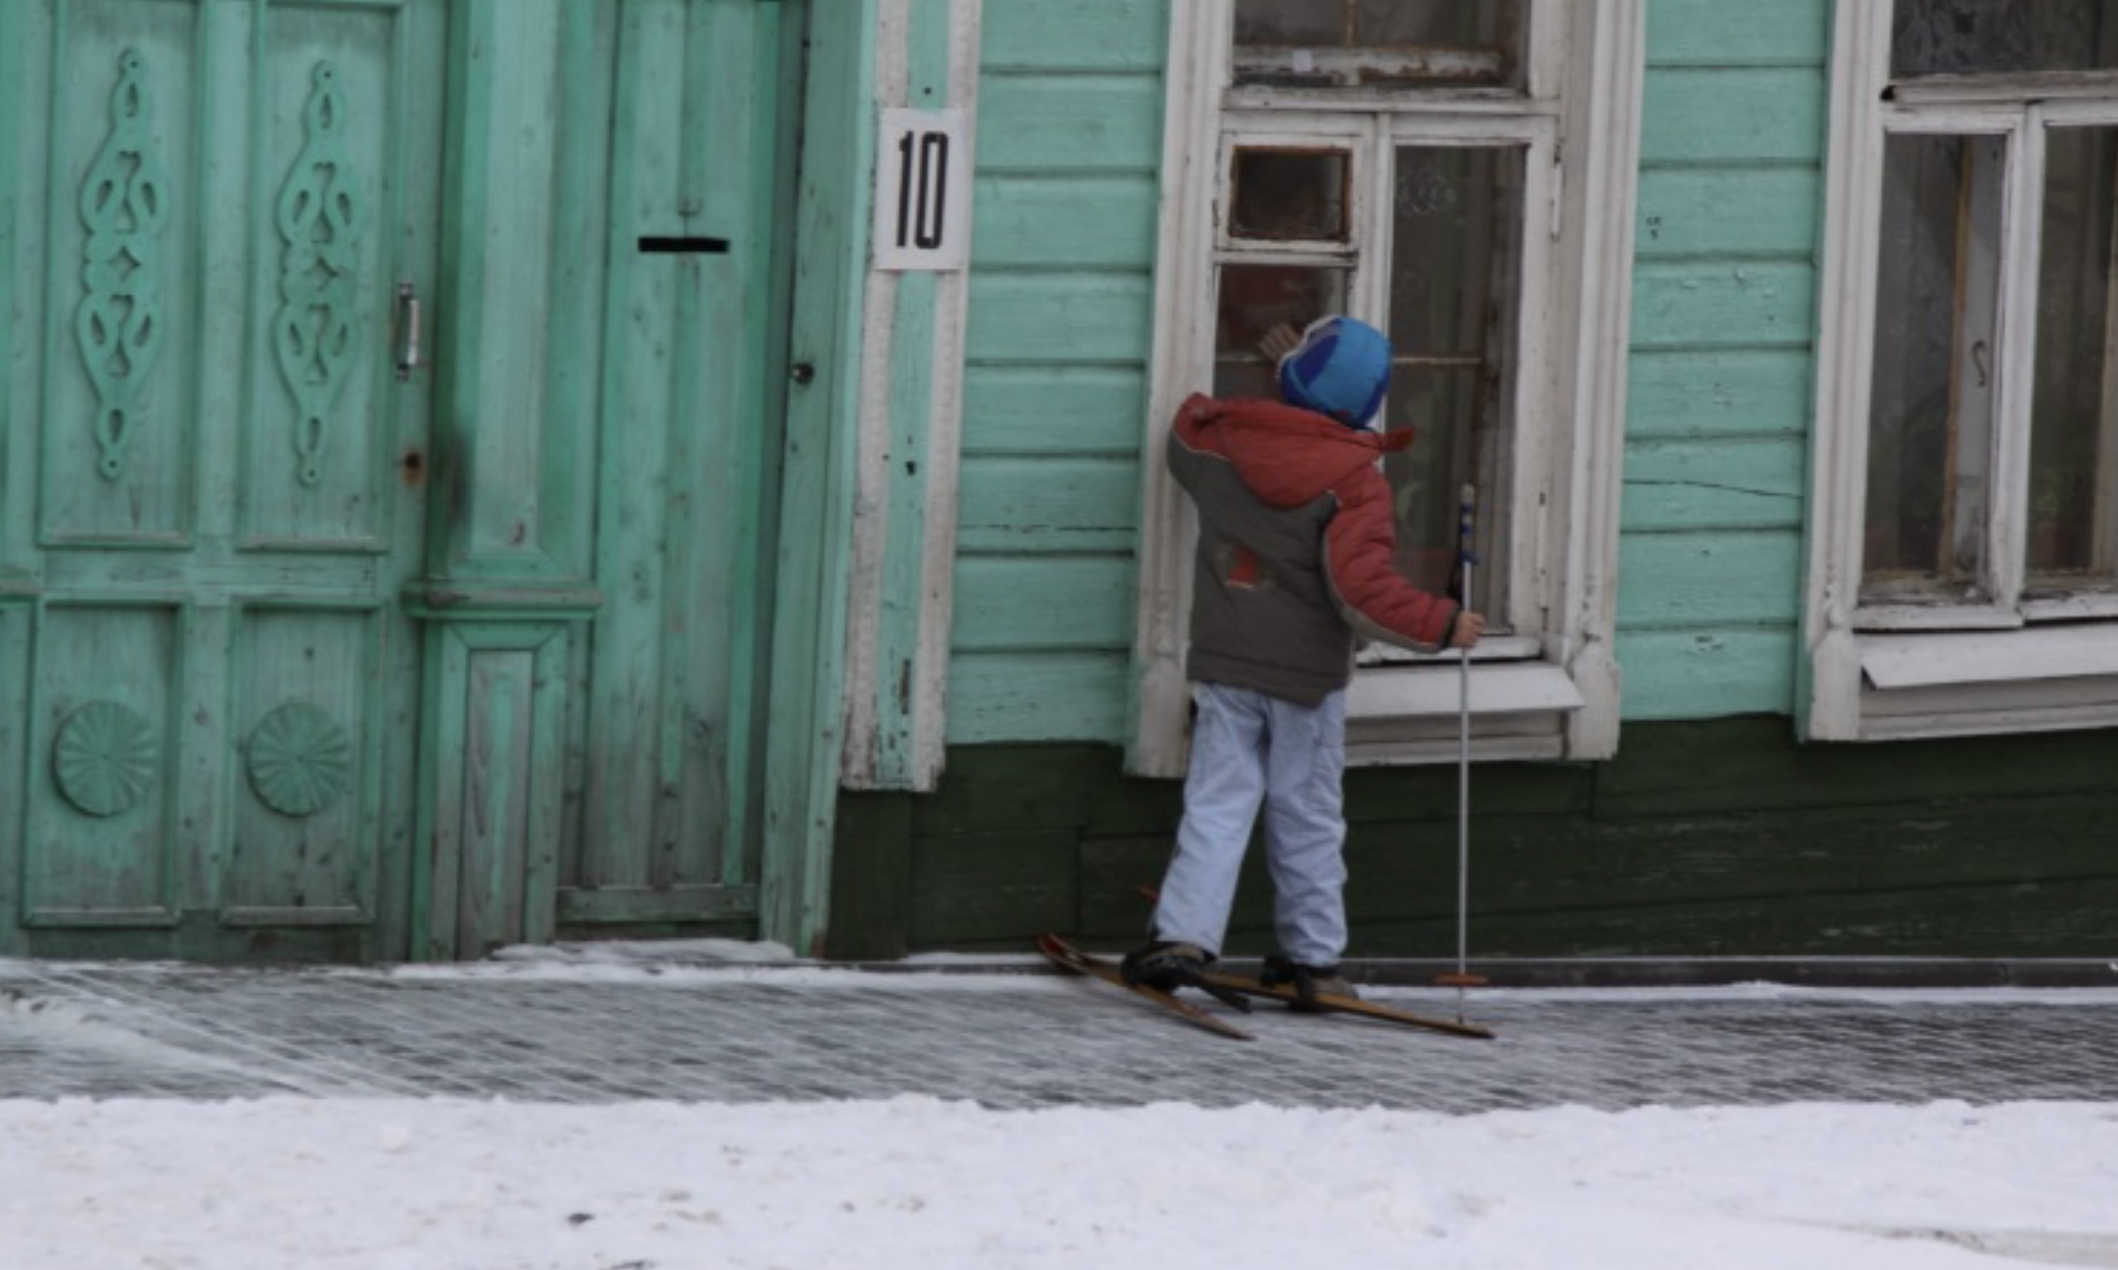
[1264,692,1347,965]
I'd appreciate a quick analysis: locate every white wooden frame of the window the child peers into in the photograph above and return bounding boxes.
[1127,0,1646,777]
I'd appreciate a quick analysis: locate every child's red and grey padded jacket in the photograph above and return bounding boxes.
[1169,396,1457,705]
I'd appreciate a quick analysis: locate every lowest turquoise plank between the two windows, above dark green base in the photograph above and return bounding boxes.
[1618,624,1798,719]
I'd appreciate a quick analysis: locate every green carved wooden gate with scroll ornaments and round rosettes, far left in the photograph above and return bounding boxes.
[0,0,447,959]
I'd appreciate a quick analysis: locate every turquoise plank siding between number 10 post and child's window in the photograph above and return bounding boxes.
[947,0,1169,745]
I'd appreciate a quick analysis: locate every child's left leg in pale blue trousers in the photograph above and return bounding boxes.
[1154,684,1271,957]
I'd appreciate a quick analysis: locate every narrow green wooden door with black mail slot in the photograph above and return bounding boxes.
[557,0,801,938]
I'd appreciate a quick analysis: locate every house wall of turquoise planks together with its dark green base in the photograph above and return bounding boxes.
[828,0,2118,957]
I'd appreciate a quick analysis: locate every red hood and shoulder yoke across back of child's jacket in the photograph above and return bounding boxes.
[1178,396,1413,508]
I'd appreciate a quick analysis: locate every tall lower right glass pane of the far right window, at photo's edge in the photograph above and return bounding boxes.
[2027,127,2118,586]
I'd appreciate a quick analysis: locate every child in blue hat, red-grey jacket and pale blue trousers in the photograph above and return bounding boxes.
[1125,318,1485,1003]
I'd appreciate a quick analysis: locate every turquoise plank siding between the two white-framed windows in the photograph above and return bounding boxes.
[1618,0,1830,722]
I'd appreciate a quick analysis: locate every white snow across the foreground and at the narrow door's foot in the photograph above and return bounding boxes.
[0,948,2118,1270]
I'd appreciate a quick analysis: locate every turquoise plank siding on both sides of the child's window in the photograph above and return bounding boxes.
[947,0,1855,745]
